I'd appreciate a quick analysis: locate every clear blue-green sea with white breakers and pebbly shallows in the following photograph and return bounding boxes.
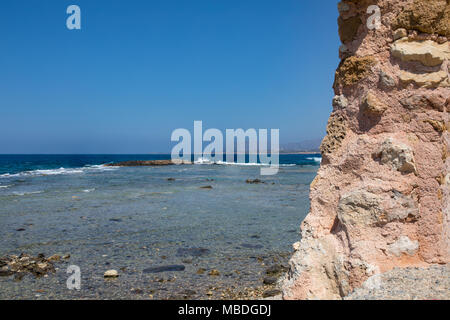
[0,154,320,299]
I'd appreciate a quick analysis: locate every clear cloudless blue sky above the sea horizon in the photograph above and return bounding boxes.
[0,0,339,153]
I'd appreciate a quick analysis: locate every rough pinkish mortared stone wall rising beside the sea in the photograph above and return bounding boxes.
[283,0,450,299]
